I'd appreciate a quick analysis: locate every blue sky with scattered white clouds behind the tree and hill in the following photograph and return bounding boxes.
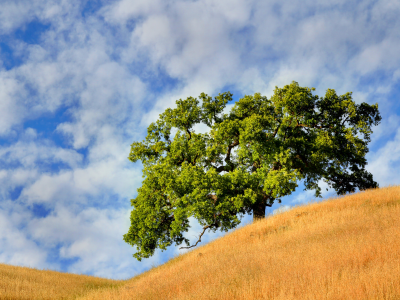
[0,0,400,279]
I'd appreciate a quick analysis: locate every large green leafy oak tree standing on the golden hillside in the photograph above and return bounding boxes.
[124,81,381,261]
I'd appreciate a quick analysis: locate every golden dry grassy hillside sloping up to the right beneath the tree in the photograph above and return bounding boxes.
[0,186,400,300]
